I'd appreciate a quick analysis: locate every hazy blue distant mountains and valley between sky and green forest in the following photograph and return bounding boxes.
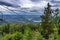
[0,15,41,23]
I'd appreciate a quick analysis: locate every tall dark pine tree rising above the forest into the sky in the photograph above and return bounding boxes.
[42,3,52,39]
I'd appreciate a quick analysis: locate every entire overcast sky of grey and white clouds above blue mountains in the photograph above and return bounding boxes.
[0,0,60,15]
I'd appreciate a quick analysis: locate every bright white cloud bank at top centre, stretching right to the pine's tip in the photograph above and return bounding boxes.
[20,0,48,8]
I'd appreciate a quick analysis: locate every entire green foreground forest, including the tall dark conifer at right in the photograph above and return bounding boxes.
[0,3,60,40]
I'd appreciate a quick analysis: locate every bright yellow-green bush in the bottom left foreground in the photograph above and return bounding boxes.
[1,32,22,40]
